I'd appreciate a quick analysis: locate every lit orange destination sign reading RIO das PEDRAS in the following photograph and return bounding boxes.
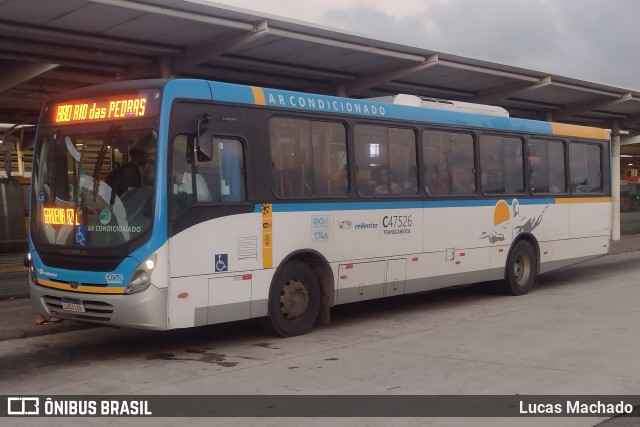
[51,94,148,124]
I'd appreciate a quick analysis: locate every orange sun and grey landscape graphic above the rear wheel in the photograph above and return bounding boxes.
[479,199,549,243]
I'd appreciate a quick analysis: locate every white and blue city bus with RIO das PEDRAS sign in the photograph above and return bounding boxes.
[28,79,611,337]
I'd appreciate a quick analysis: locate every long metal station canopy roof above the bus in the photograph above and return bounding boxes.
[0,0,640,134]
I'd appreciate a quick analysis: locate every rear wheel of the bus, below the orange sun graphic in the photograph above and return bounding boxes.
[499,240,538,295]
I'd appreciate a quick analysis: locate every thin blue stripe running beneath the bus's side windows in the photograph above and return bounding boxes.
[254,197,555,213]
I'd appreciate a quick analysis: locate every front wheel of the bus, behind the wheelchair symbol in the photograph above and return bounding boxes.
[266,261,320,337]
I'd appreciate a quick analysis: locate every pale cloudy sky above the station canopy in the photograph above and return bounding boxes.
[208,0,640,90]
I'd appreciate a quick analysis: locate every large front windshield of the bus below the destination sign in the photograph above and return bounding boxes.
[31,128,157,248]
